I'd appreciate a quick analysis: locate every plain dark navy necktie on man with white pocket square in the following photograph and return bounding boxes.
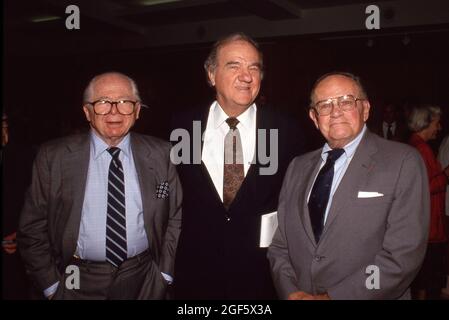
[308,149,344,243]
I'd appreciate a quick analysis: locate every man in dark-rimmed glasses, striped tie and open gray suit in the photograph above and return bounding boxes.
[18,72,182,299]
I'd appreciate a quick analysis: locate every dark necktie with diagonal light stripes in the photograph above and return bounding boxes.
[106,147,127,267]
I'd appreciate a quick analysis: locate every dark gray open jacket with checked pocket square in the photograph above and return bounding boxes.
[18,133,182,296]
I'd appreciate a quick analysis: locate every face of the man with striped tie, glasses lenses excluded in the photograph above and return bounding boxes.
[83,73,140,146]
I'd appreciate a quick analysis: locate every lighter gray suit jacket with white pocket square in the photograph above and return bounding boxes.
[268,131,430,299]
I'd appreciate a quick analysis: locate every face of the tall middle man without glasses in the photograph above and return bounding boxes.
[208,40,262,117]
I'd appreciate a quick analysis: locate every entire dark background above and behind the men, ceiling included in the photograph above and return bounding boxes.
[2,0,449,152]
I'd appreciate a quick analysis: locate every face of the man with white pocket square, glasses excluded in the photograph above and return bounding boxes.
[309,75,370,148]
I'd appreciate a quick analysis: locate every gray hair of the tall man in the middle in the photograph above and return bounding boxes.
[204,32,263,85]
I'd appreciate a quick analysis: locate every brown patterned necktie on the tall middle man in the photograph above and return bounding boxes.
[223,117,245,209]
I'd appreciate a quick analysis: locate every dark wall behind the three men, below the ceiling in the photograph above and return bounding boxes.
[3,31,449,148]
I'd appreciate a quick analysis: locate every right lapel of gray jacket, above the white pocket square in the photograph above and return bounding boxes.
[321,131,377,238]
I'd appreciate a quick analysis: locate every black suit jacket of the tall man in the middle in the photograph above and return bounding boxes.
[174,108,303,299]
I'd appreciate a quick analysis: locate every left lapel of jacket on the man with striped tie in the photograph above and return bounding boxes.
[61,134,90,259]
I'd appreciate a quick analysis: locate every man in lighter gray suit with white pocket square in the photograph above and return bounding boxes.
[268,72,430,300]
